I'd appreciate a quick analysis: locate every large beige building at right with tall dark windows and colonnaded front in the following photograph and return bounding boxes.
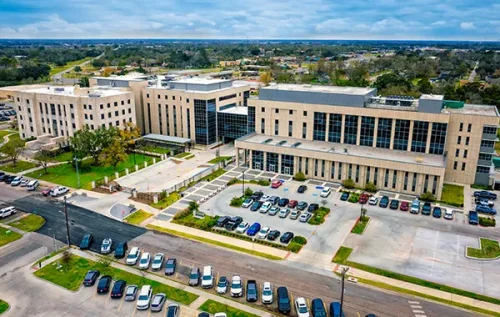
[235,84,499,198]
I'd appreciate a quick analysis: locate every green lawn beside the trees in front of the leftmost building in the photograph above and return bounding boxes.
[26,155,151,189]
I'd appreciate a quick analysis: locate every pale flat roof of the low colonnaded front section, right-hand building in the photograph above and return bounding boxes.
[238,134,446,168]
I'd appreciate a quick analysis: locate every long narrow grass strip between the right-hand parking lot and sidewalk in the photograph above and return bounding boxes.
[332,247,500,305]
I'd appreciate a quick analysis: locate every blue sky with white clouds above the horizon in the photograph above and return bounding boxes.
[0,0,500,41]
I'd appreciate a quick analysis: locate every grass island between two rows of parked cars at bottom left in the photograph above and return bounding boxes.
[35,255,198,305]
